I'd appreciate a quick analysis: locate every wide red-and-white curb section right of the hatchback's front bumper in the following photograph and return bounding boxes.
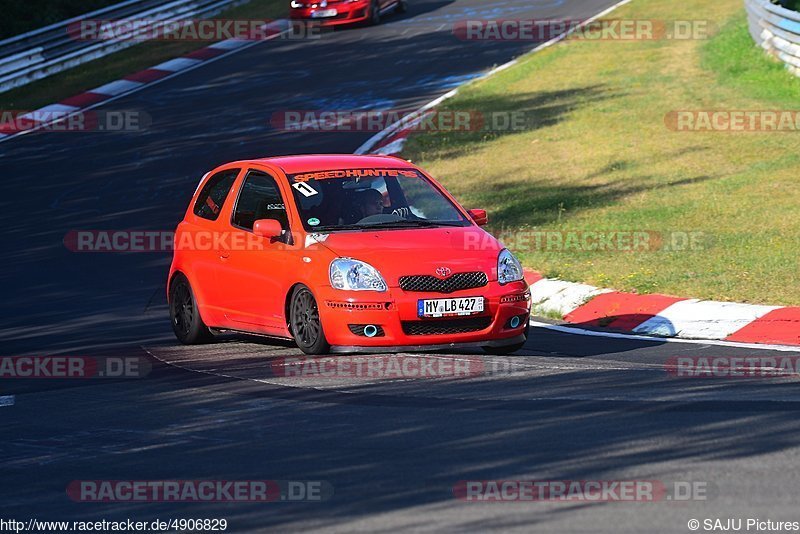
[525,271,800,345]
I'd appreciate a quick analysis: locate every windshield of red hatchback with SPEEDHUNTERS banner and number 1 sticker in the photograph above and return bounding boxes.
[289,169,471,232]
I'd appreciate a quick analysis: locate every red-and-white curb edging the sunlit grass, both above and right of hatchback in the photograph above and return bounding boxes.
[355,0,800,346]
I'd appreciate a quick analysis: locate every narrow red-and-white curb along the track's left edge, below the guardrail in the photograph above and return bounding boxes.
[0,19,289,142]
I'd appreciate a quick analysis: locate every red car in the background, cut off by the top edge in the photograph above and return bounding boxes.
[289,0,408,26]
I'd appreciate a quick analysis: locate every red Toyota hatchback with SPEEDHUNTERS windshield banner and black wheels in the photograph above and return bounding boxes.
[167,155,531,354]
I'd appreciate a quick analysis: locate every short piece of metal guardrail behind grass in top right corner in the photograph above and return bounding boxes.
[744,0,800,76]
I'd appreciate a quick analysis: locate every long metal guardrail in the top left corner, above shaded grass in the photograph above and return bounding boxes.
[0,0,248,93]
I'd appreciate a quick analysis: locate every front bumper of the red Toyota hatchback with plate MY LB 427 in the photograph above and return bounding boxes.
[317,281,531,352]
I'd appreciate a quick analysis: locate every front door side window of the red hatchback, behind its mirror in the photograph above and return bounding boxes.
[231,171,289,232]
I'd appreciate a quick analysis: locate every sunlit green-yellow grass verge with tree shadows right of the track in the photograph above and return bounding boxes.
[404,0,800,305]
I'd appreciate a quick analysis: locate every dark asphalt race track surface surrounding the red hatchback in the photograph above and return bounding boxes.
[0,0,800,533]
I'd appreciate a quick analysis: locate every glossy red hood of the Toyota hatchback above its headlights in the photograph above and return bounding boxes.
[310,226,503,287]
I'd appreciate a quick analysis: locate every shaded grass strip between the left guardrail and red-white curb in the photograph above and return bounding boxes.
[0,0,288,110]
